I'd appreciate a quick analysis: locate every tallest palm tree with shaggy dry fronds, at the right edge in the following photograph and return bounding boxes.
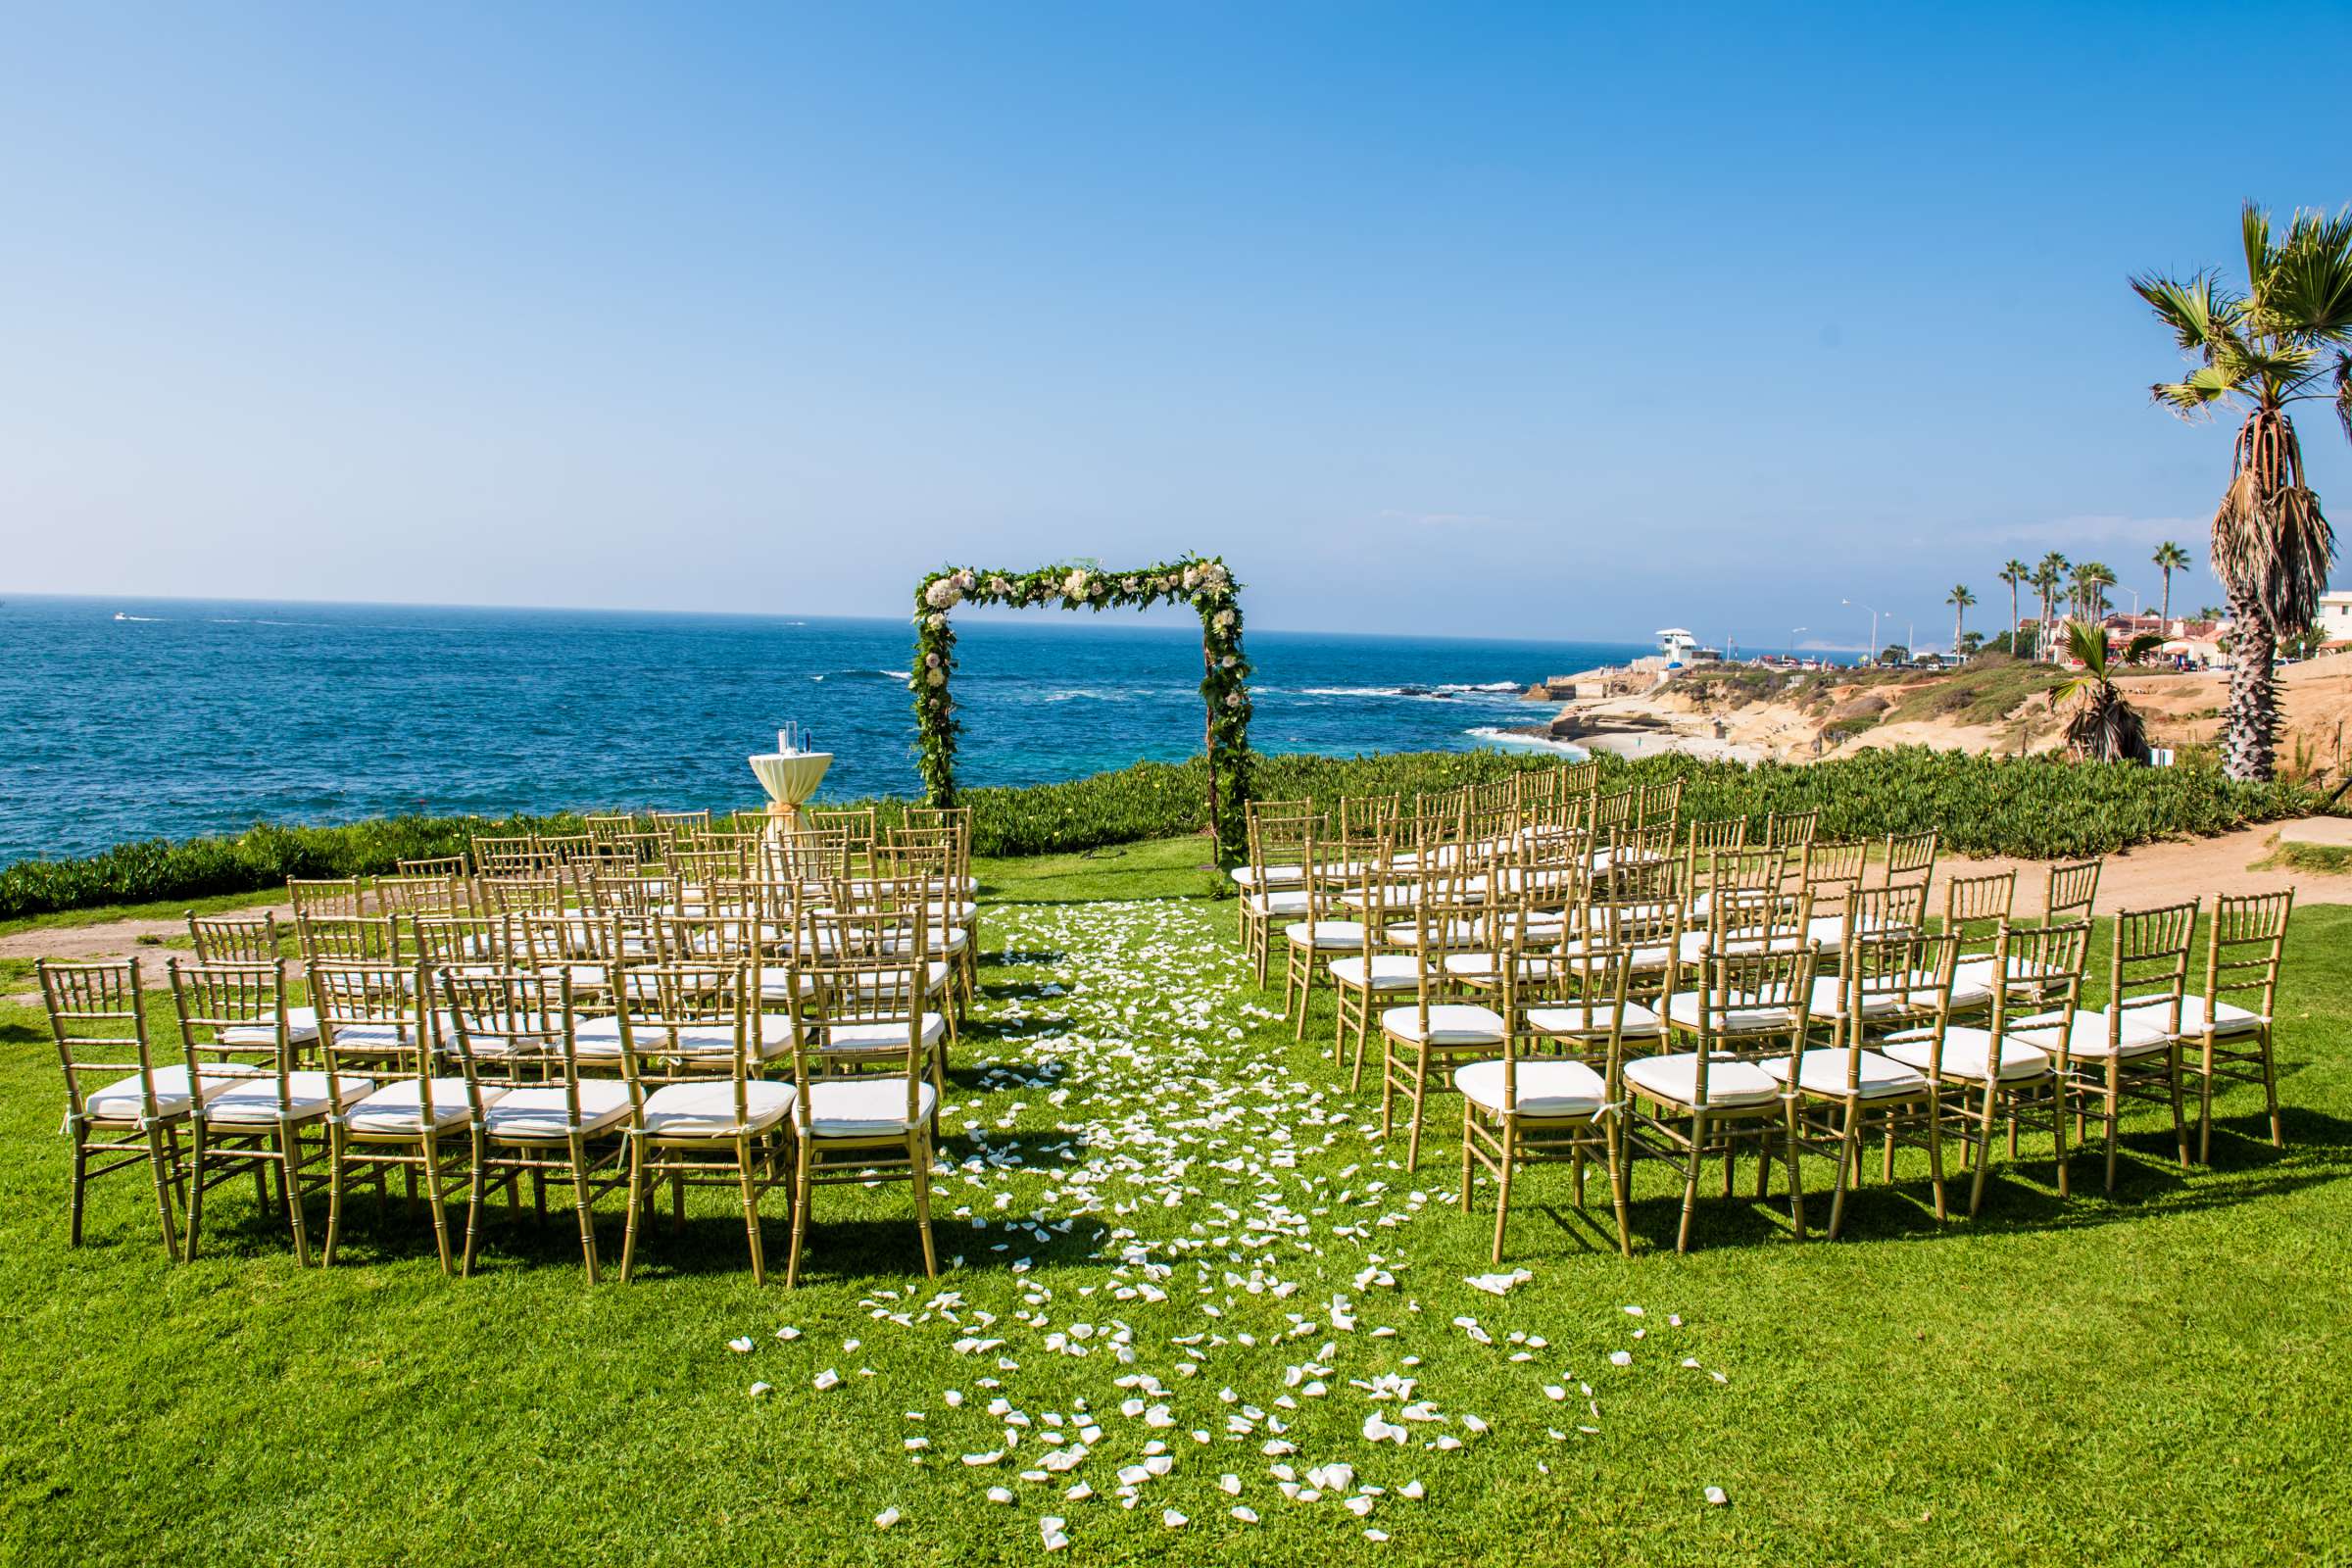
[2131,202,2352,778]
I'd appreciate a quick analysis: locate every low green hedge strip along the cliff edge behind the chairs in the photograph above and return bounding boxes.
[0,748,2322,919]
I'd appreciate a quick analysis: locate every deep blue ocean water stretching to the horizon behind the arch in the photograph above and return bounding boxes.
[0,597,1648,865]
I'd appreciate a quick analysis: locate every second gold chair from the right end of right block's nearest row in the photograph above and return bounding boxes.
[2011,898,2197,1195]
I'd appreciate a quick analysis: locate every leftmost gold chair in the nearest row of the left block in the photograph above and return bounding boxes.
[33,959,197,1257]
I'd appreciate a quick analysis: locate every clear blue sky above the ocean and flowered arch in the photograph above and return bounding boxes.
[0,5,2352,644]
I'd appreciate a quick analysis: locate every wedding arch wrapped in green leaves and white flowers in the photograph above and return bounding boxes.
[907,555,1249,860]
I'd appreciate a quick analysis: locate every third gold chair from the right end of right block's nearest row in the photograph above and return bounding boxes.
[1880,921,2091,1220]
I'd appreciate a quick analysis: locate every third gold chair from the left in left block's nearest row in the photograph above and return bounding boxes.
[311,959,504,1274]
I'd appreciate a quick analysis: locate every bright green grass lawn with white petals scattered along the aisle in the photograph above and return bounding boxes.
[0,842,2352,1563]
